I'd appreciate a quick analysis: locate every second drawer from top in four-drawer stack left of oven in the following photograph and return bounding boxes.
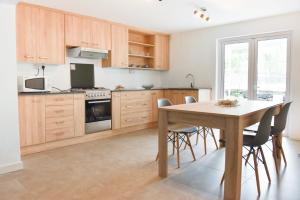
[46,105,74,118]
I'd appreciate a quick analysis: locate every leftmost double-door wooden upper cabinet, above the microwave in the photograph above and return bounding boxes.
[16,3,65,64]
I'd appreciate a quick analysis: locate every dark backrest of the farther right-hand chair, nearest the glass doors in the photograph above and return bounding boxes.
[272,102,292,134]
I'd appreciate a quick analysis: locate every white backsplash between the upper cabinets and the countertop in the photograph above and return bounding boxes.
[18,58,162,89]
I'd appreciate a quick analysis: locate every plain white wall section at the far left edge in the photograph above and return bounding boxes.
[0,4,22,174]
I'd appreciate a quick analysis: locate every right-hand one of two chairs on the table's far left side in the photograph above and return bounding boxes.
[184,96,219,154]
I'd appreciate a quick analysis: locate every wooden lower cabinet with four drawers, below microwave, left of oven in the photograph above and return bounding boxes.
[19,94,85,147]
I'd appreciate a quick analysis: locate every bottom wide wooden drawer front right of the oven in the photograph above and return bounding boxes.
[121,112,152,127]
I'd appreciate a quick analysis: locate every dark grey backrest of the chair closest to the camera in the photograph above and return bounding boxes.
[253,107,275,146]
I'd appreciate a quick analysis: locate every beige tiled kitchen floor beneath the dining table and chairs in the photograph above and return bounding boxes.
[0,129,300,200]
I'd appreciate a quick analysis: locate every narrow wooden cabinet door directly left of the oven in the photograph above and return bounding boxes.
[74,94,85,136]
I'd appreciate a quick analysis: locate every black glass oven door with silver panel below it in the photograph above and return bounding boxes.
[85,99,111,133]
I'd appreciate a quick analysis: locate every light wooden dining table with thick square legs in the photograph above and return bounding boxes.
[158,100,282,200]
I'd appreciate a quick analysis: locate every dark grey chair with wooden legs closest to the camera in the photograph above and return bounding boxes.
[221,107,275,196]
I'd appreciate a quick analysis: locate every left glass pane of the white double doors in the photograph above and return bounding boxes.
[224,43,249,99]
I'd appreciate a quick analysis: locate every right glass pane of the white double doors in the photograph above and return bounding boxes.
[257,38,288,101]
